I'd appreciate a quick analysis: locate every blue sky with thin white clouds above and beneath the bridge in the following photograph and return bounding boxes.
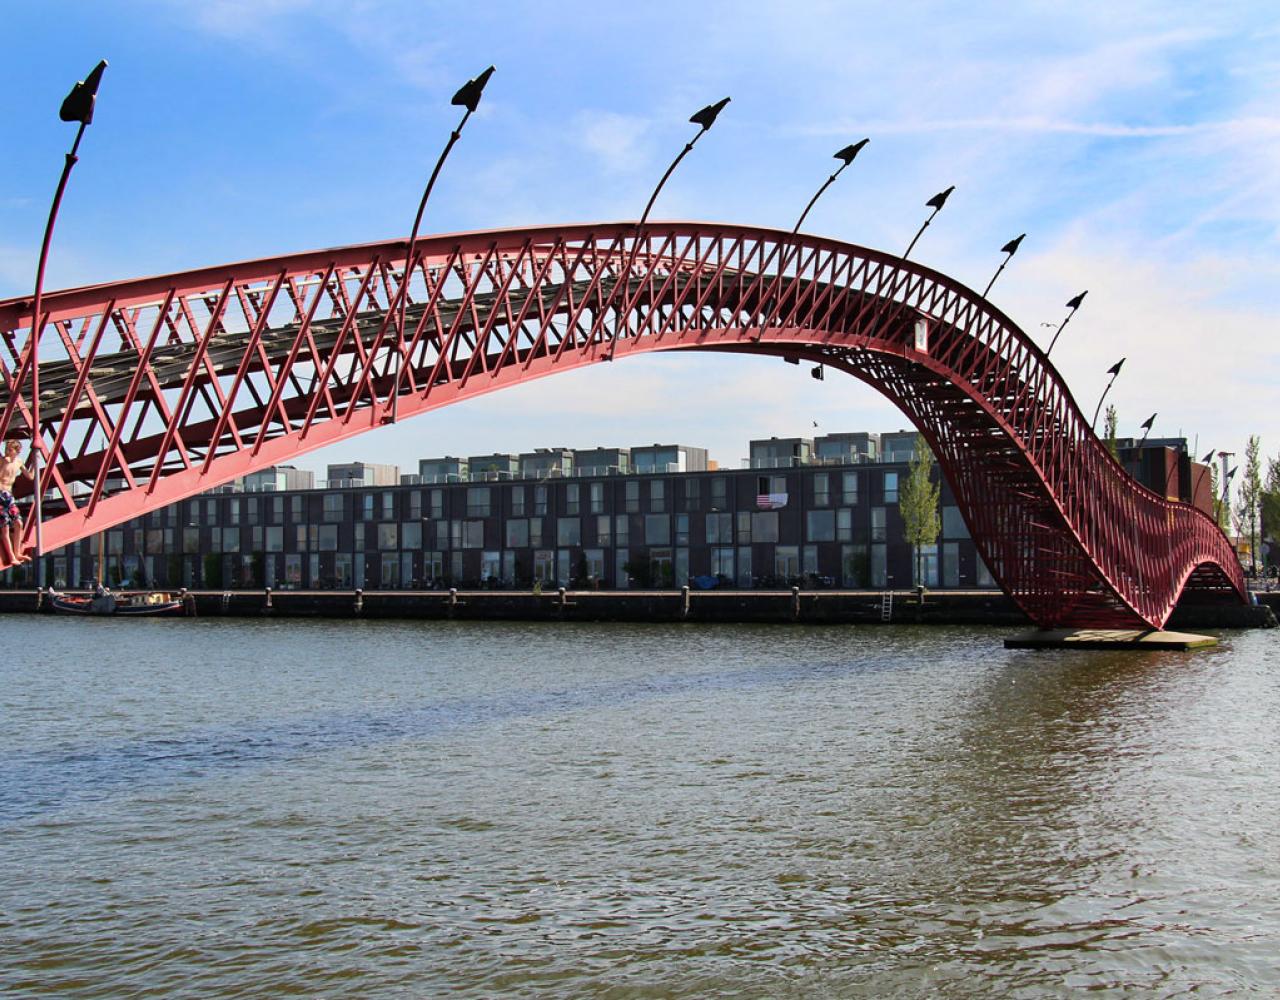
[0,0,1280,483]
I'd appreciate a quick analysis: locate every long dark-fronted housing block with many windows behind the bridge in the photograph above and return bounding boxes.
[17,430,1218,589]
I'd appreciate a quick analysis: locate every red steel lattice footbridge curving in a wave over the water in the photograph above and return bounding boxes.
[0,223,1247,627]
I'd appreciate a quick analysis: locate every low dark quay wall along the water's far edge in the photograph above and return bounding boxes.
[0,590,1280,629]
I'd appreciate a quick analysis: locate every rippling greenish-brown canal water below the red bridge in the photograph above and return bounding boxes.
[0,616,1280,997]
